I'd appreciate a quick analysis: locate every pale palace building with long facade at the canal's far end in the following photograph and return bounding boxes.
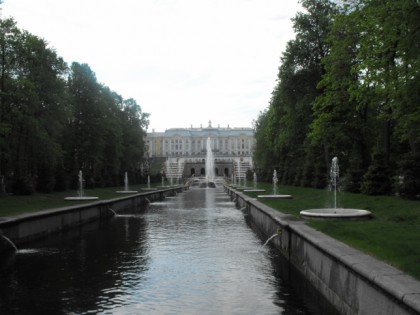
[146,121,255,176]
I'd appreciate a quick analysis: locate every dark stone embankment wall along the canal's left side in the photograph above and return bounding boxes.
[0,186,185,253]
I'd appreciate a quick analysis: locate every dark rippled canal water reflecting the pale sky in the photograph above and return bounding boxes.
[0,188,334,314]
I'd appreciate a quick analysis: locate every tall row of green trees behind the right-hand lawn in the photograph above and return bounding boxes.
[255,0,420,197]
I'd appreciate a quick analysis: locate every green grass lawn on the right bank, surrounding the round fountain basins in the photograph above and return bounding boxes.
[243,184,420,280]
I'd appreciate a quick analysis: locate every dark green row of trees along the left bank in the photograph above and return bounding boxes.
[0,18,149,194]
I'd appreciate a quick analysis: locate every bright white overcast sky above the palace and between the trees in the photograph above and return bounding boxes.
[1,0,302,131]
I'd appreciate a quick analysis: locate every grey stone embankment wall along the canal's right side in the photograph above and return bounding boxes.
[225,187,420,315]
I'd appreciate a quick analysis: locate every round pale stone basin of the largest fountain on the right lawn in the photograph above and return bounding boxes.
[300,208,372,220]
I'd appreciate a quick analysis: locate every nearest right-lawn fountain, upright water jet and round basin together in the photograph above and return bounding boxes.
[300,157,371,219]
